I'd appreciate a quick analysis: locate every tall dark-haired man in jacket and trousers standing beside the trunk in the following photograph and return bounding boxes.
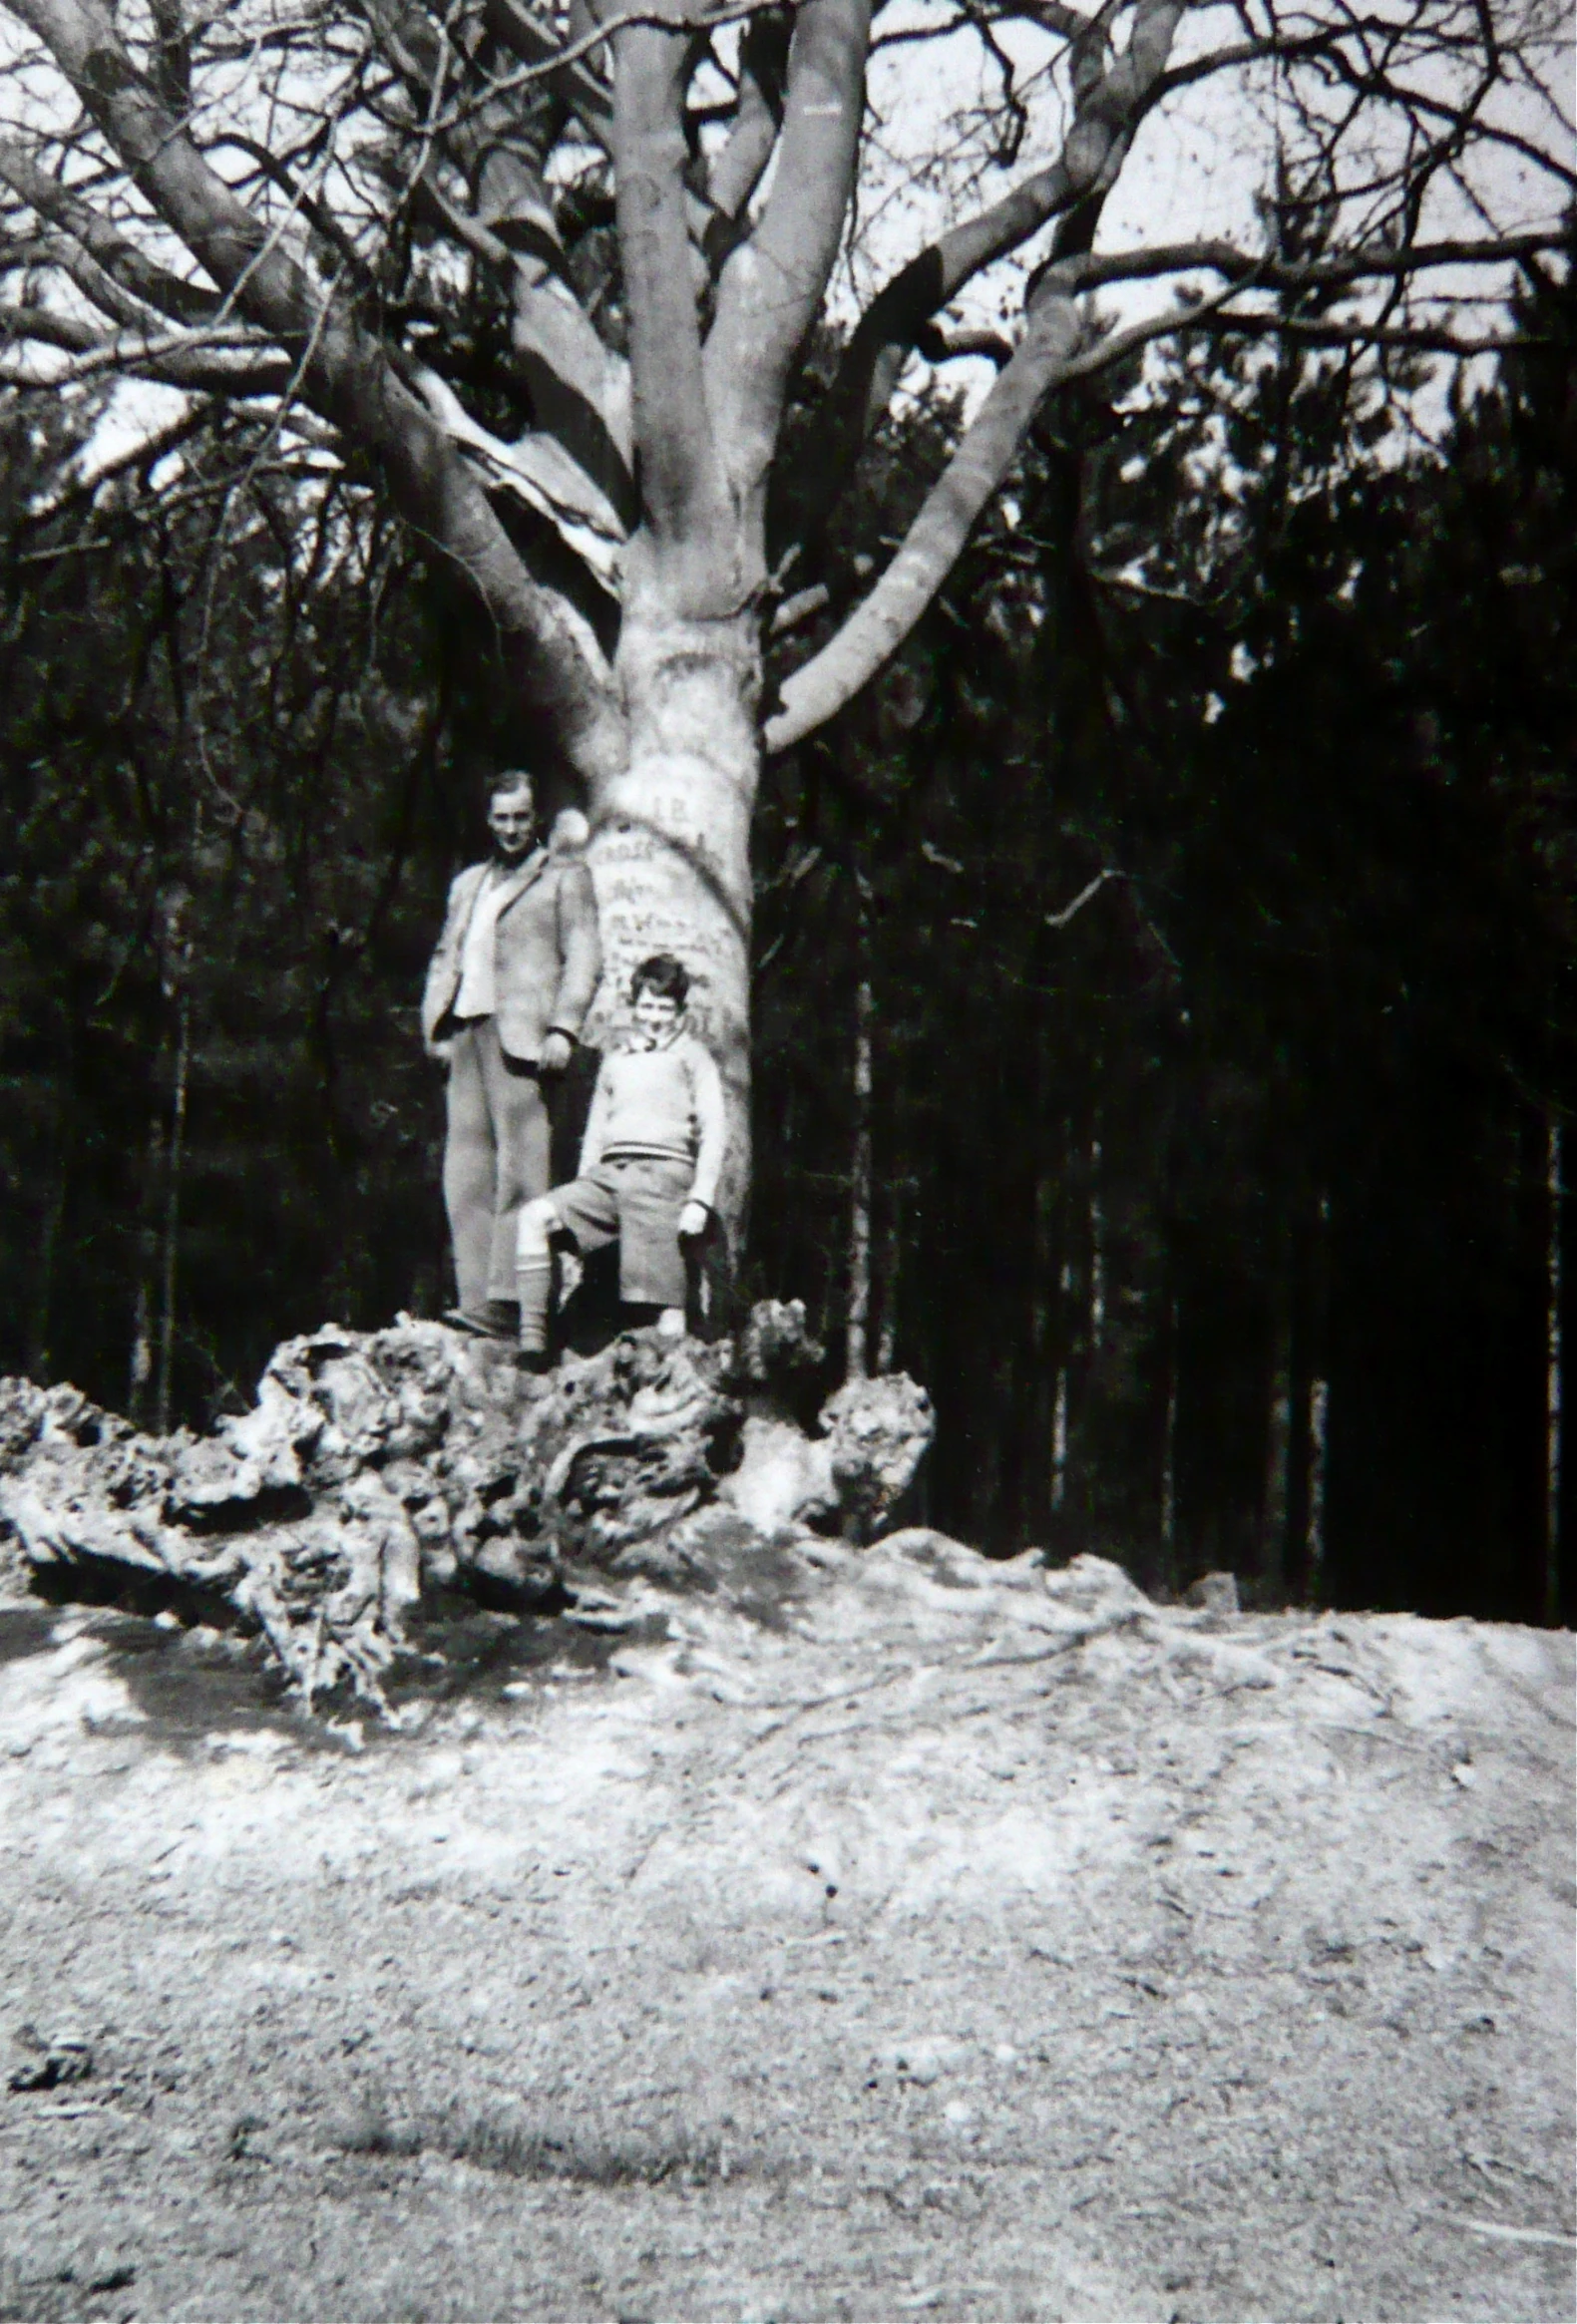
[423,772,601,1339]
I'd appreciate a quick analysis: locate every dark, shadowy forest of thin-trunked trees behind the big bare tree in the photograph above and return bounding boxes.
[0,254,1577,1620]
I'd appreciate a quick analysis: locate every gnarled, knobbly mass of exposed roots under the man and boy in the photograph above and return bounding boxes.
[0,1302,934,1713]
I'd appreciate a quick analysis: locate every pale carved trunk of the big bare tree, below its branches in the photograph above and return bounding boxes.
[590,613,762,1248]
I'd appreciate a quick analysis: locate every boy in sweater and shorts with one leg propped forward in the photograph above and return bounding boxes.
[516,953,727,1364]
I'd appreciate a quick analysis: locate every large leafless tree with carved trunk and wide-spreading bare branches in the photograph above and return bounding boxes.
[0,0,1577,1204]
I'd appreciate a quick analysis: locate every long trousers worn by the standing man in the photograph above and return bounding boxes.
[444,1018,551,1316]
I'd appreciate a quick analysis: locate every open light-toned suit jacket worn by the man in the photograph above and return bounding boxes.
[423,848,601,1064]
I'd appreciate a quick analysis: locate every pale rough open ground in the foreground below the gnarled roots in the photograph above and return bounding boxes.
[0,1555,1575,2324]
